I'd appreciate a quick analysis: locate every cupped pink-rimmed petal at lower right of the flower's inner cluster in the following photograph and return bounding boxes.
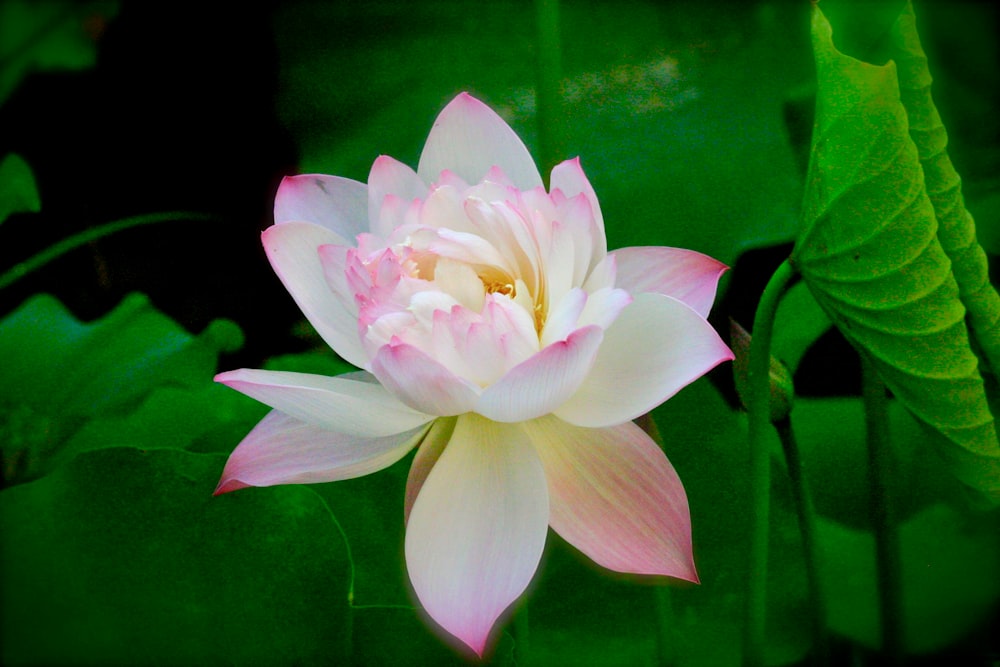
[475,326,604,422]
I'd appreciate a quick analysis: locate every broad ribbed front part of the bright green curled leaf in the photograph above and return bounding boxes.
[792,9,1000,498]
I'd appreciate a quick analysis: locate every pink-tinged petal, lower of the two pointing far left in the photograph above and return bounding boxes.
[215,410,430,495]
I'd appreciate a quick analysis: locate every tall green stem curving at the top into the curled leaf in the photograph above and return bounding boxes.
[743,260,795,667]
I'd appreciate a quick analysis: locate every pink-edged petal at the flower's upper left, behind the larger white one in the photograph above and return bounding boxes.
[274,174,368,245]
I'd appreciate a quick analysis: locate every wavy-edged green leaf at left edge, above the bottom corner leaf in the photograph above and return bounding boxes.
[0,294,244,483]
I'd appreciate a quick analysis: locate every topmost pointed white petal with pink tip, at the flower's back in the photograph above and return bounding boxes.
[417,93,542,190]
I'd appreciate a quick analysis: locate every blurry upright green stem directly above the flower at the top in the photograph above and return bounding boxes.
[535,0,563,180]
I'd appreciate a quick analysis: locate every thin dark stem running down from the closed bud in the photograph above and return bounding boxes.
[774,417,830,667]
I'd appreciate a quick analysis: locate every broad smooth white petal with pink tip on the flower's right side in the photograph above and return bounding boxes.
[555,293,733,427]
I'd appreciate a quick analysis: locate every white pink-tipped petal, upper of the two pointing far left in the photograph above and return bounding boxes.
[215,368,432,438]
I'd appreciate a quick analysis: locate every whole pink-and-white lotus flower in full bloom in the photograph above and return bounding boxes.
[216,94,732,655]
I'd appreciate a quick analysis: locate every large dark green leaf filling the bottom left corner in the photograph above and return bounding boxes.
[0,448,351,665]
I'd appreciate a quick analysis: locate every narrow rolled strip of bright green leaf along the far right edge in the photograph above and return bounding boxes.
[891,1,1000,374]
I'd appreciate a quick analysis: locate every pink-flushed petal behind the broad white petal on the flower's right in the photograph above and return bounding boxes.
[610,247,729,317]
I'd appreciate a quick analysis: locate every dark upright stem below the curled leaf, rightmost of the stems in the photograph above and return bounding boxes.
[861,355,903,665]
